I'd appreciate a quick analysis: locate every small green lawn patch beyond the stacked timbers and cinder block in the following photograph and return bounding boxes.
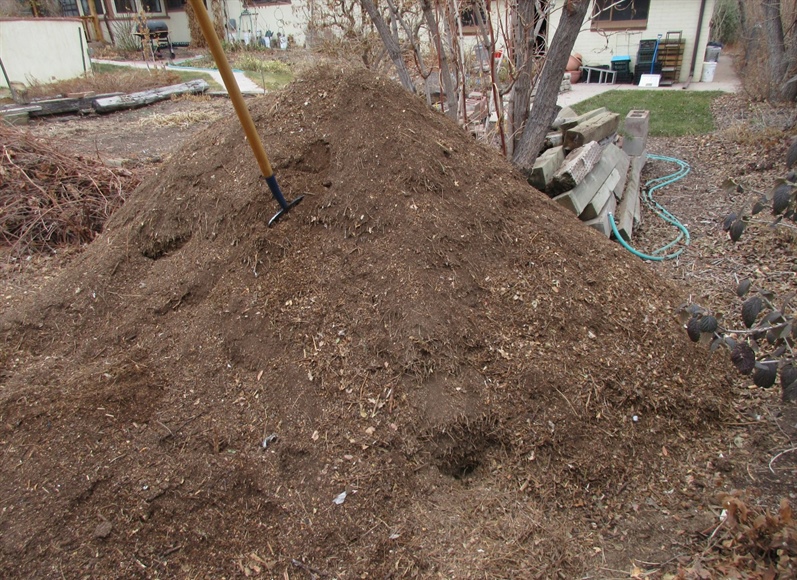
[572,89,722,137]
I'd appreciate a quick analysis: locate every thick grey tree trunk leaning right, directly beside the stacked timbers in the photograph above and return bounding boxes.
[513,0,590,174]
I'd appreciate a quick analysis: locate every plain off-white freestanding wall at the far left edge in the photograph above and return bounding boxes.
[0,18,91,87]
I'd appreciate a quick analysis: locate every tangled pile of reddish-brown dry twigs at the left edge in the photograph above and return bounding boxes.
[0,125,139,254]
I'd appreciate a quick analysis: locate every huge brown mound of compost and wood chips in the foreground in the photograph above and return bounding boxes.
[0,68,730,578]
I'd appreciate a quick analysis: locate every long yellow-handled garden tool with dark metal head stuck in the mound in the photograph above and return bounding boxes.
[188,0,303,226]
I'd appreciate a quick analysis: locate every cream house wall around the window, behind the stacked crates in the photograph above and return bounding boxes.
[549,0,715,83]
